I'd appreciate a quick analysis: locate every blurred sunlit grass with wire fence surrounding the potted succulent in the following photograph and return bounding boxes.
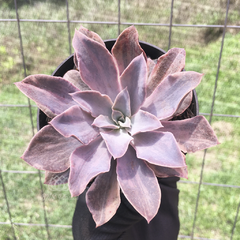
[0,0,240,240]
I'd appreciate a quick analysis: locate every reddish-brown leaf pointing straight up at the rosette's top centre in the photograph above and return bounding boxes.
[112,26,147,75]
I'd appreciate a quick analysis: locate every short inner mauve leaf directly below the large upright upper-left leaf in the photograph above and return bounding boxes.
[72,91,113,117]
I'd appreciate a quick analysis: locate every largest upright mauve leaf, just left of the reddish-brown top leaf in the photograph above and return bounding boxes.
[73,31,120,101]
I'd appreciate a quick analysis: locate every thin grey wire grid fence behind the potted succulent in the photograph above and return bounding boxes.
[0,0,240,240]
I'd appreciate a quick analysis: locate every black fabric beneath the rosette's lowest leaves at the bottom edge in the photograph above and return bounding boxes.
[72,177,180,240]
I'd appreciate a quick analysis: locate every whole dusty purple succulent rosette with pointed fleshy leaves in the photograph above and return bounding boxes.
[13,26,218,226]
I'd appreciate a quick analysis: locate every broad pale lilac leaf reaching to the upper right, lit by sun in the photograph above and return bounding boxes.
[142,72,203,120]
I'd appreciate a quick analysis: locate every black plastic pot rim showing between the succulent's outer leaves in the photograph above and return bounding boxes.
[37,39,199,130]
